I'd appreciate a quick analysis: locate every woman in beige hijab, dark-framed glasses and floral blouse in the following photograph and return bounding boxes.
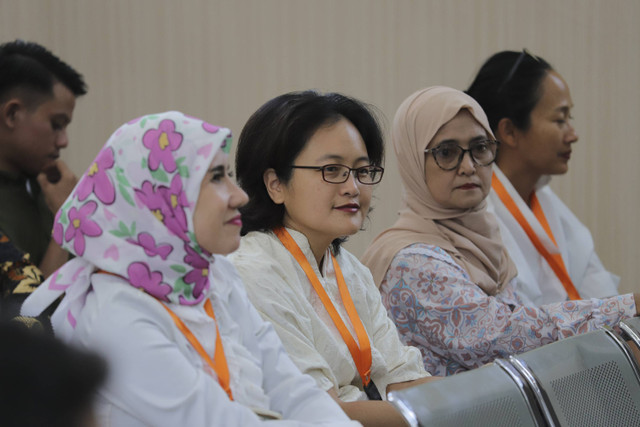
[362,86,637,375]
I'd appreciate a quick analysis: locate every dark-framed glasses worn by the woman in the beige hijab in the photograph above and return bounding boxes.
[424,139,500,171]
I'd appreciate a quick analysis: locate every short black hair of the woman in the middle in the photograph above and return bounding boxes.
[236,91,384,249]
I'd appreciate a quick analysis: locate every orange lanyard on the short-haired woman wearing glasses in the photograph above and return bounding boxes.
[273,231,371,387]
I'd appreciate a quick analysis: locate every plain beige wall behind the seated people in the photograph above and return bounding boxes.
[0,0,640,291]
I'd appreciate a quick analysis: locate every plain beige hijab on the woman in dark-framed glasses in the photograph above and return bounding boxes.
[362,86,517,295]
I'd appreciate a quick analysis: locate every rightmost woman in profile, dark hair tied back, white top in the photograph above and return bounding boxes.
[467,50,619,304]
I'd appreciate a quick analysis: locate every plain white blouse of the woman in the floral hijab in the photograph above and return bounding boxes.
[60,258,359,427]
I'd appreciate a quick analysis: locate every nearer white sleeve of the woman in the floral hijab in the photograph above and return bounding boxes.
[77,295,268,427]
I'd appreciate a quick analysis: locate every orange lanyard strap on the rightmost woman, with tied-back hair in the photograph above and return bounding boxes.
[491,173,581,300]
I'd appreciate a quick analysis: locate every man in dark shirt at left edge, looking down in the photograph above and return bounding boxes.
[0,40,86,310]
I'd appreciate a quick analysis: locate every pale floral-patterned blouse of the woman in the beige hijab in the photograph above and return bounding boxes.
[380,244,635,375]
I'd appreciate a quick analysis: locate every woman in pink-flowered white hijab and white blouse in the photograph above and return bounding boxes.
[22,112,360,426]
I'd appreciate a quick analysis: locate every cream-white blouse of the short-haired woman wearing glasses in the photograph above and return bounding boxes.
[230,229,429,401]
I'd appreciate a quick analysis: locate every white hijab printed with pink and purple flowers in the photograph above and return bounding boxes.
[22,111,231,338]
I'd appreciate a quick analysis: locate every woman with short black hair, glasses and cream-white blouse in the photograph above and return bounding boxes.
[231,91,430,425]
